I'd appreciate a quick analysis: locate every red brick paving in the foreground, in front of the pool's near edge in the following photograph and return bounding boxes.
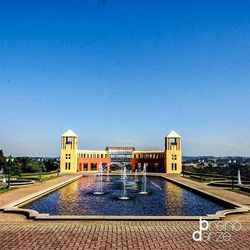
[0,217,250,250]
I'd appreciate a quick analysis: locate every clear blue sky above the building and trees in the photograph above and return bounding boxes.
[0,0,250,156]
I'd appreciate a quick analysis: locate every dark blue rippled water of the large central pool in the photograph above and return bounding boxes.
[25,176,229,216]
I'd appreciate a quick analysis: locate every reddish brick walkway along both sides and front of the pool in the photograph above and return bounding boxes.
[0,176,250,250]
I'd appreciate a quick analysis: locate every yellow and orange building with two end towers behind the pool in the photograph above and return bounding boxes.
[60,129,182,174]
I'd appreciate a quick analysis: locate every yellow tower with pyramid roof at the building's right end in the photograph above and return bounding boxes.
[165,130,182,174]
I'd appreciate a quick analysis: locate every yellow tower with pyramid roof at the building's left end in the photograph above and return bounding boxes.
[60,129,78,173]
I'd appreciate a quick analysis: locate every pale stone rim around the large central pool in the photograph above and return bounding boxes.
[0,173,250,221]
